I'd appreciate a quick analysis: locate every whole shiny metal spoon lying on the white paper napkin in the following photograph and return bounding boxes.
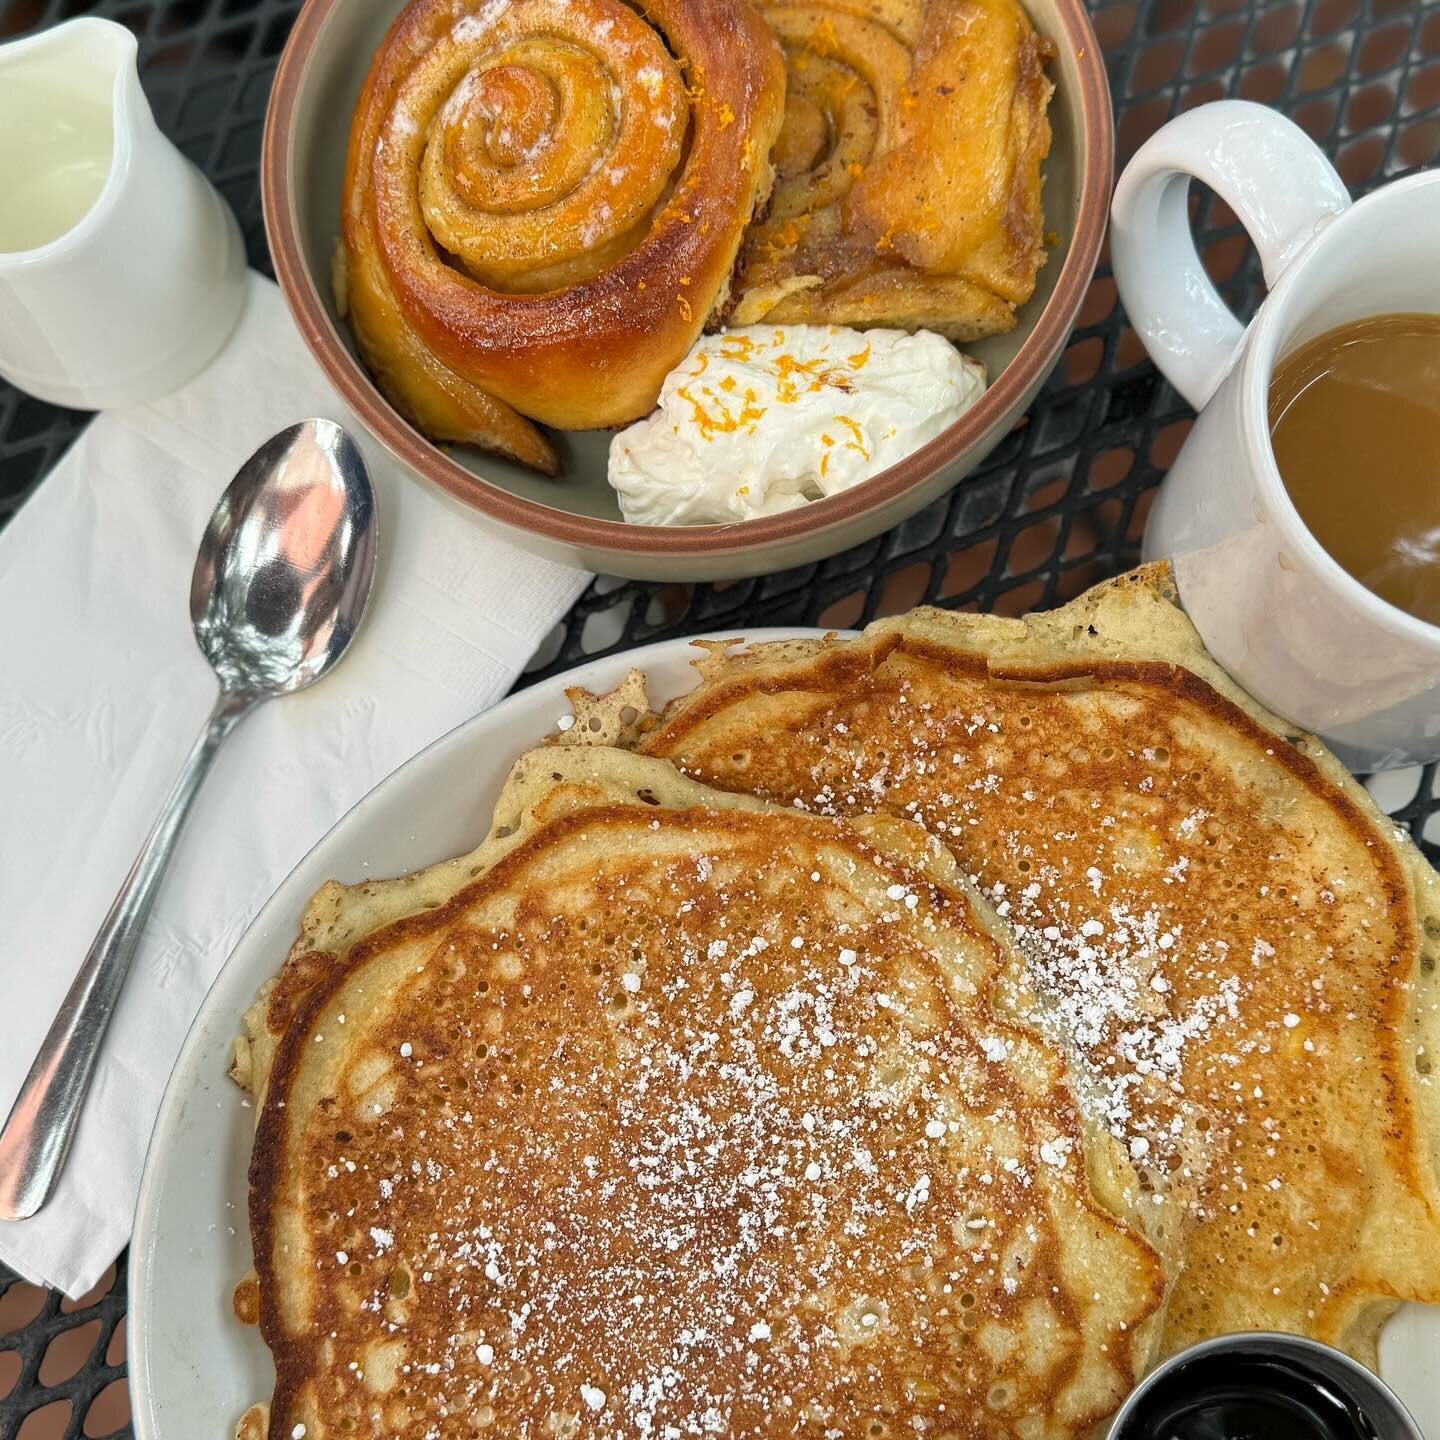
[0,420,374,1220]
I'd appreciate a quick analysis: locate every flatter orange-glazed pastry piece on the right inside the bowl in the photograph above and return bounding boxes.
[733,0,1054,340]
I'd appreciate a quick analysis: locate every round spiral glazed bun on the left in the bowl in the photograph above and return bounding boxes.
[340,0,785,472]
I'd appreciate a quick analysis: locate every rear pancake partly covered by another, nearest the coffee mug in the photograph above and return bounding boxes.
[632,570,1440,1365]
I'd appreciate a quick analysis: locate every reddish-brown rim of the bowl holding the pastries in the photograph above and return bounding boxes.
[261,0,1115,556]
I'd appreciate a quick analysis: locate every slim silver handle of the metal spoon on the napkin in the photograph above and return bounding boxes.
[0,690,259,1220]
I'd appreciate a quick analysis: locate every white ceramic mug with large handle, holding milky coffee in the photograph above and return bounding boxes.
[1110,101,1440,769]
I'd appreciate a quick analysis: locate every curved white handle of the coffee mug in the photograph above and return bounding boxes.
[1110,99,1351,410]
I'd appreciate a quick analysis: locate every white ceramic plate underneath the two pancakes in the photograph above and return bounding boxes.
[128,631,1440,1440]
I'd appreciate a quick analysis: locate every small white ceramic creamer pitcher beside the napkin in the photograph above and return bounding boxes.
[0,19,245,409]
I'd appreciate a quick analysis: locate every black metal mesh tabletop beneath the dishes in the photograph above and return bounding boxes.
[0,0,1440,1440]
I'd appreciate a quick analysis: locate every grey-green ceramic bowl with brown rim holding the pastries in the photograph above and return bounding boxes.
[261,0,1113,580]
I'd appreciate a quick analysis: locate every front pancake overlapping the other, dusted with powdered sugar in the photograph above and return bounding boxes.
[245,749,1164,1440]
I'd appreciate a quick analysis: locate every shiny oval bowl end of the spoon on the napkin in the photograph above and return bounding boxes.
[190,420,376,696]
